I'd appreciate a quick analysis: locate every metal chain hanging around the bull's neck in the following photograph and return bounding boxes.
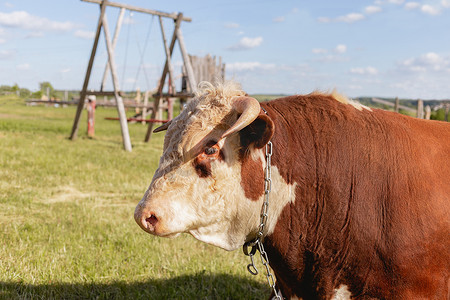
[243,141,283,300]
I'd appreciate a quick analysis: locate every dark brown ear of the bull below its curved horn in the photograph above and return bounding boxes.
[239,112,275,149]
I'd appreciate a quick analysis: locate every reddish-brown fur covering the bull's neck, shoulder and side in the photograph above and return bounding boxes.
[250,94,450,299]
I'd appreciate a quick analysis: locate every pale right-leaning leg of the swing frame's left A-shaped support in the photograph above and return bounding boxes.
[102,11,131,151]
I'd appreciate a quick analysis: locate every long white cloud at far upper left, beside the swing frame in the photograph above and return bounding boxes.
[0,11,76,31]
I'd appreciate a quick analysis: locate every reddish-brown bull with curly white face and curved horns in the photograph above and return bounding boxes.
[135,82,450,299]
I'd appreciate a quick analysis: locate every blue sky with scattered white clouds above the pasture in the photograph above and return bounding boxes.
[0,0,450,99]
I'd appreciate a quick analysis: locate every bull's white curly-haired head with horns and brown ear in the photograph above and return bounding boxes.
[134,82,274,250]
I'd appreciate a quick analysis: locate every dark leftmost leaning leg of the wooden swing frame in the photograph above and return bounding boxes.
[70,0,108,140]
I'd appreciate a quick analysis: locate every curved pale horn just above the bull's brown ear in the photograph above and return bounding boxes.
[222,96,261,138]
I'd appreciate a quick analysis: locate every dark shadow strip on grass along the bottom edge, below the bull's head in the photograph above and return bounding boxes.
[0,273,270,299]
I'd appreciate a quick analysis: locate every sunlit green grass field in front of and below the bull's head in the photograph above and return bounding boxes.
[0,97,270,299]
